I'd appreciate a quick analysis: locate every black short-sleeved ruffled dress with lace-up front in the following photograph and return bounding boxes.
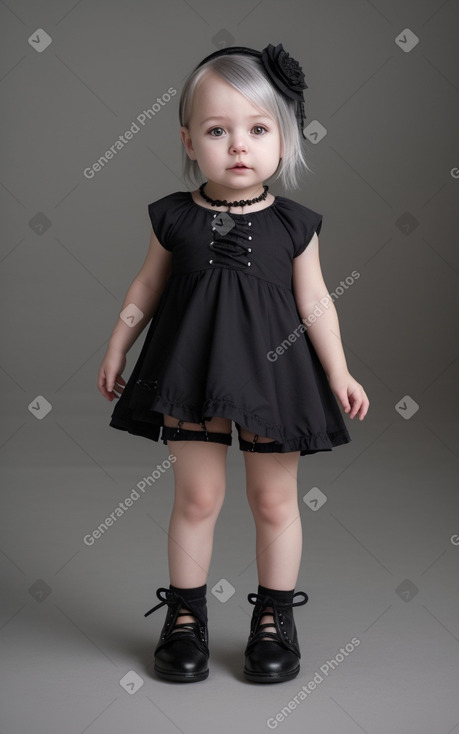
[110,191,351,456]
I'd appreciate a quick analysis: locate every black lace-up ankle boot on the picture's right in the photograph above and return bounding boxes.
[244,586,308,683]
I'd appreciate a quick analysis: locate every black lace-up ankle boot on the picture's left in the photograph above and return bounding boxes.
[144,584,209,683]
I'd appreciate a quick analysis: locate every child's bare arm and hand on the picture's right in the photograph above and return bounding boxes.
[292,234,369,420]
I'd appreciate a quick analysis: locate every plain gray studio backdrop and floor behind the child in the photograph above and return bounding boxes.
[0,0,459,734]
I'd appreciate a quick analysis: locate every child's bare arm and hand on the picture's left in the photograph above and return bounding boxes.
[97,232,172,401]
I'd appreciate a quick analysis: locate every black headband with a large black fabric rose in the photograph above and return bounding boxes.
[196,43,308,140]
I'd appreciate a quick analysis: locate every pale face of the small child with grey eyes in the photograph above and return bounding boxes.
[180,73,282,191]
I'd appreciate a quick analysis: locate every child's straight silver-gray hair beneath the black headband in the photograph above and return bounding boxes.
[179,54,311,189]
